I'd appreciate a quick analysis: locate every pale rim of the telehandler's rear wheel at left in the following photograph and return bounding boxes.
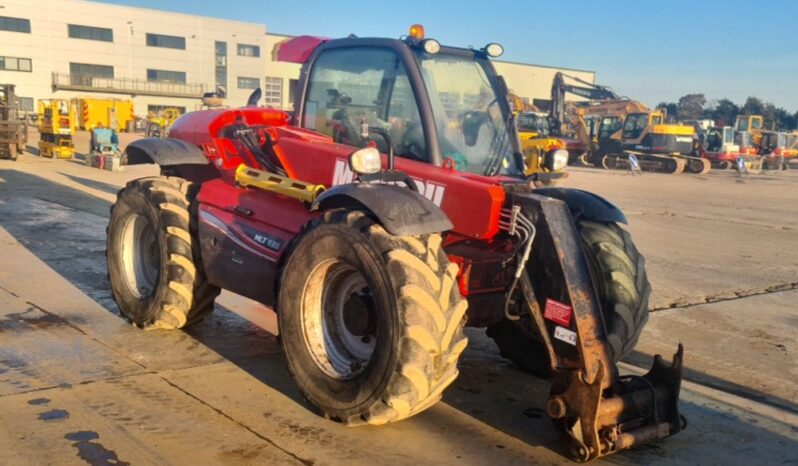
[120,214,161,299]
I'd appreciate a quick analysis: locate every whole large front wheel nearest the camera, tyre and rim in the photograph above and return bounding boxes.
[278,211,467,425]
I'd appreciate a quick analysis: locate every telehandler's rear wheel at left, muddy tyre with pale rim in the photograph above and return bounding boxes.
[106,177,219,330]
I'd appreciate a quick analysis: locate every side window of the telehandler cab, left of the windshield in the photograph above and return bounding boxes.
[303,47,427,160]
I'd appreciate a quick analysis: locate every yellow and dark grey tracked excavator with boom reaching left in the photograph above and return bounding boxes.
[550,73,711,174]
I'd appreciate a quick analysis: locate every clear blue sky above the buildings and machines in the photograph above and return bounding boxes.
[103,0,798,113]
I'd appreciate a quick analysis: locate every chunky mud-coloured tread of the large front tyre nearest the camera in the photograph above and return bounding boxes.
[283,210,468,426]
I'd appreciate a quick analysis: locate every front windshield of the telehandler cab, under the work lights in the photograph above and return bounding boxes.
[419,53,522,175]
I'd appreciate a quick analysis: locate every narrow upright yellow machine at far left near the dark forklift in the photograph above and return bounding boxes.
[39,99,75,159]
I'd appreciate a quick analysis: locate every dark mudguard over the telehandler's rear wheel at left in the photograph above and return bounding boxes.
[125,138,210,167]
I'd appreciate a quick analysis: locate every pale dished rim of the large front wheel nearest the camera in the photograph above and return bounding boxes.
[301,259,377,380]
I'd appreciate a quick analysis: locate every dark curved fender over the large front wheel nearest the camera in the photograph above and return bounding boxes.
[311,183,454,236]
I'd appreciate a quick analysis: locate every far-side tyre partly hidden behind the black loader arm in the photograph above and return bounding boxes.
[487,220,651,376]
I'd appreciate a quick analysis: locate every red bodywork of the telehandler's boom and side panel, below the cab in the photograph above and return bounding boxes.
[169,107,513,302]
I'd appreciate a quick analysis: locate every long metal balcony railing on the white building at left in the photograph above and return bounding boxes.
[53,73,205,98]
